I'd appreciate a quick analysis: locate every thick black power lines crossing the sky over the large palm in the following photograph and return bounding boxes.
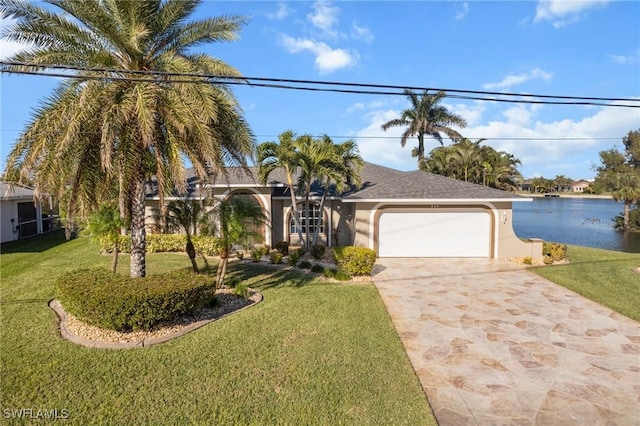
[0,61,640,108]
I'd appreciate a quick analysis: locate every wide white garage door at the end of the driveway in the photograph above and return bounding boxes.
[378,211,491,257]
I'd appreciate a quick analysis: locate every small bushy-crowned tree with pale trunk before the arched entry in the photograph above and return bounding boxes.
[212,195,266,289]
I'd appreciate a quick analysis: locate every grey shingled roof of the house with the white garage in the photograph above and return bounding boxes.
[147,163,527,202]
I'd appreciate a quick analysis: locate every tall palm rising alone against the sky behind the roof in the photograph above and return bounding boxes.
[382,89,467,165]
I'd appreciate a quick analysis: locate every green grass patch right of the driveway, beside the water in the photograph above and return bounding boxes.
[530,246,640,321]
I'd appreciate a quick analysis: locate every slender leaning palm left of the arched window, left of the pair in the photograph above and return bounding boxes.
[258,130,304,246]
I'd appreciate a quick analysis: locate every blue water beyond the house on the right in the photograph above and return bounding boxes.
[513,198,640,253]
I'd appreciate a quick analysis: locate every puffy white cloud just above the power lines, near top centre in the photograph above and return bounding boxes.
[280,34,359,73]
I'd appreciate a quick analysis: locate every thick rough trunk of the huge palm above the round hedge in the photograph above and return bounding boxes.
[131,174,147,278]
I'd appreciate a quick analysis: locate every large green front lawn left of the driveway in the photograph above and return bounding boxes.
[0,233,435,425]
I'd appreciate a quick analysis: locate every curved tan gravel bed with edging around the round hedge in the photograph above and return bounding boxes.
[49,289,263,349]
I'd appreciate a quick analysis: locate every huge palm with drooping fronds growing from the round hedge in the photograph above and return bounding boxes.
[0,0,254,277]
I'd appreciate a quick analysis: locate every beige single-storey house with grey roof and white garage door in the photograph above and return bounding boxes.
[147,163,542,258]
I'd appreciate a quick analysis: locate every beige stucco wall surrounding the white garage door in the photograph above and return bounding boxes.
[353,202,542,258]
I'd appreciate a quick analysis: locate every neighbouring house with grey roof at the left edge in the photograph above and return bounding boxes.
[0,182,57,243]
